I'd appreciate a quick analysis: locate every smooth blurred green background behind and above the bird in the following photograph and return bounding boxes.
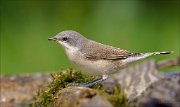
[0,0,180,74]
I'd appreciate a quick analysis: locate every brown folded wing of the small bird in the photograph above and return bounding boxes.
[81,41,133,60]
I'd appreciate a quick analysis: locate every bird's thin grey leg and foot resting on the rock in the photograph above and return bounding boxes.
[70,74,108,87]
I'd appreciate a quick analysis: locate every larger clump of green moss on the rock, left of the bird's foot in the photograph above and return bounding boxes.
[33,69,93,107]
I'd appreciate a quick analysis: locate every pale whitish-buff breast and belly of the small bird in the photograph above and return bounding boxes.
[66,48,110,75]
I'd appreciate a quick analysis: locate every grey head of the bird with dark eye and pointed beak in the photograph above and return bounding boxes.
[48,30,87,48]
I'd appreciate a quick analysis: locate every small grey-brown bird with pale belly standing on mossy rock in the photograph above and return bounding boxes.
[48,30,172,87]
